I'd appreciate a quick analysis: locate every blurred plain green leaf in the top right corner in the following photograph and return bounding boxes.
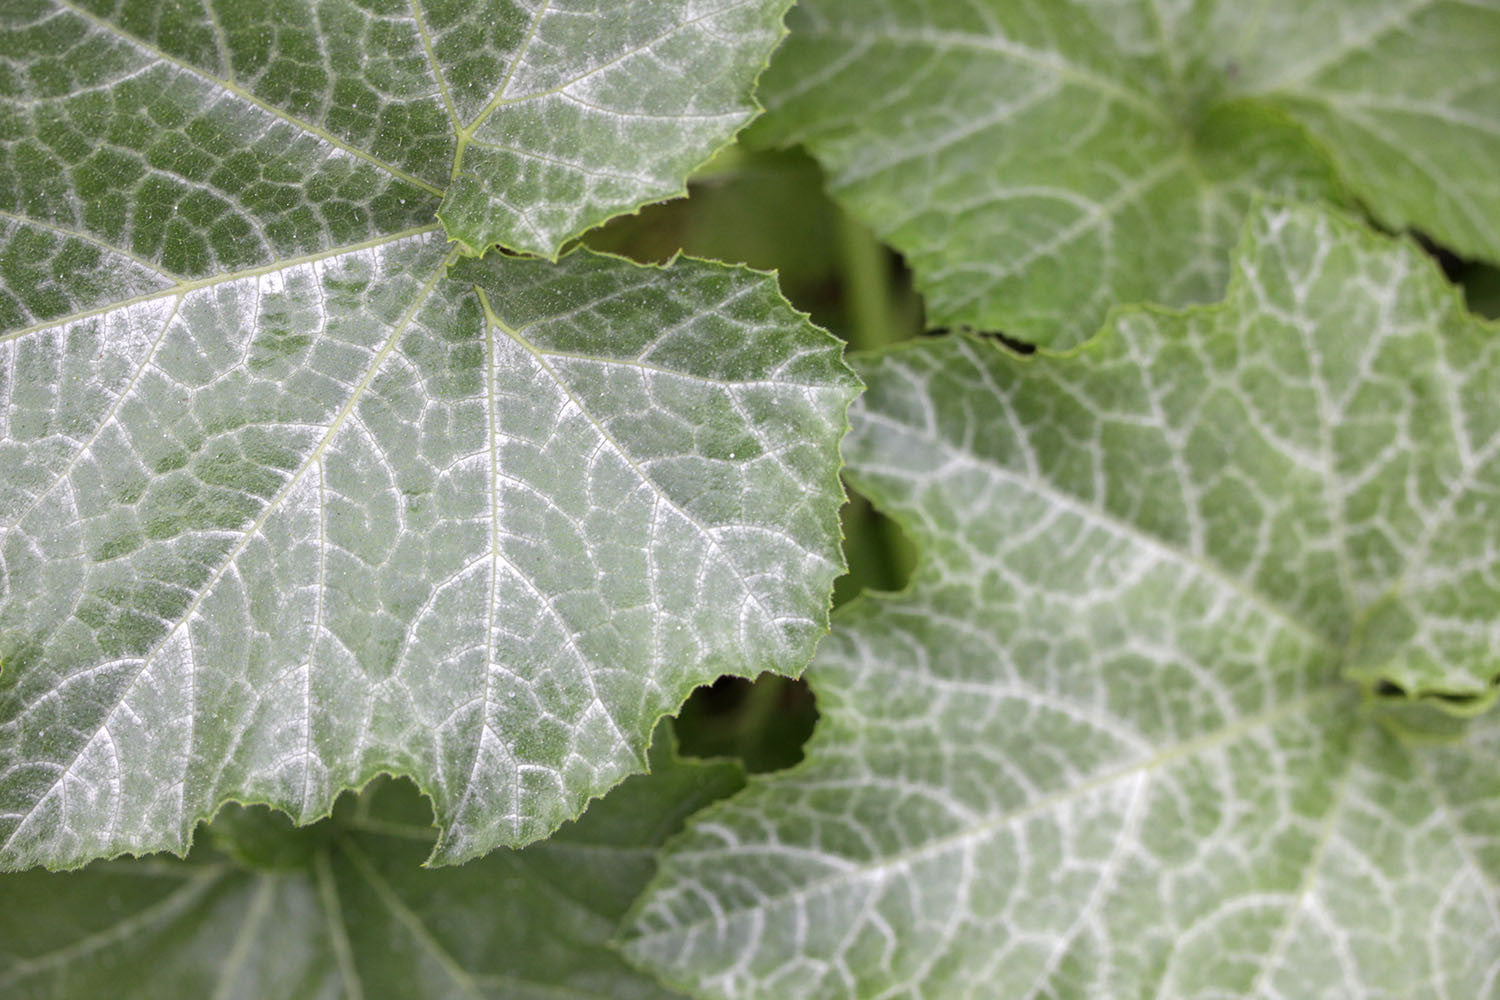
[762,0,1500,345]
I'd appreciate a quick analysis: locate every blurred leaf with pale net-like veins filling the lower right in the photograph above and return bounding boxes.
[626,208,1500,999]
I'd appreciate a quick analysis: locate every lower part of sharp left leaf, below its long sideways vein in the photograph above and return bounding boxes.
[0,232,857,868]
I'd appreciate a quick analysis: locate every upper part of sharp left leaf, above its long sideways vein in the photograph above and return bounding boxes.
[0,0,789,305]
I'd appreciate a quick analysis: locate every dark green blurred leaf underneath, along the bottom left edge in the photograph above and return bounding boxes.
[0,728,743,1000]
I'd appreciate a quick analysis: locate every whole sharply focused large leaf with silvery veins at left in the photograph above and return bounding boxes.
[0,0,854,868]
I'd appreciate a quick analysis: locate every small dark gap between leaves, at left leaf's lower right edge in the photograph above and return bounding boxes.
[677,673,818,774]
